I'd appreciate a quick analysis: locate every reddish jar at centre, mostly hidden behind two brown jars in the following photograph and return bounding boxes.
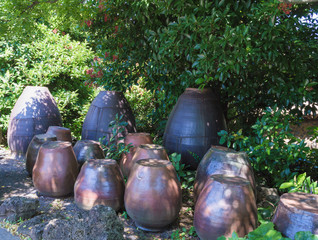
[120,133,153,177]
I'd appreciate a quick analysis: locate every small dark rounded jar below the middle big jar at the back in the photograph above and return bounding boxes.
[73,140,105,168]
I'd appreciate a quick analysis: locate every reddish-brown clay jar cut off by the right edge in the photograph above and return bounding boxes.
[273,193,318,239]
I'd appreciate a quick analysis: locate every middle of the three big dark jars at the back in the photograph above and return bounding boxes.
[82,91,136,144]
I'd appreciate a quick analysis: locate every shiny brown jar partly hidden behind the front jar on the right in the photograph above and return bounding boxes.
[193,146,256,200]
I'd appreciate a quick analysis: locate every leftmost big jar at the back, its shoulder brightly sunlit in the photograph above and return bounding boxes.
[7,86,62,158]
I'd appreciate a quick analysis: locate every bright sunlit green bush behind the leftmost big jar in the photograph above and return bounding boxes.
[0,26,94,138]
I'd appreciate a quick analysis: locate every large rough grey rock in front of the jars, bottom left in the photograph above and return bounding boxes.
[18,204,124,240]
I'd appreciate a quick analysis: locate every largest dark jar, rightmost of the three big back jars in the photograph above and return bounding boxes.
[163,88,226,169]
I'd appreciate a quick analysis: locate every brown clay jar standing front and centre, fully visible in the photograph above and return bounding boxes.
[125,159,182,232]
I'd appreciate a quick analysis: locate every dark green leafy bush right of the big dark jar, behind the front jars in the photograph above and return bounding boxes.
[219,107,315,187]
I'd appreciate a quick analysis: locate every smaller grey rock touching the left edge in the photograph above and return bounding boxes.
[0,197,39,222]
